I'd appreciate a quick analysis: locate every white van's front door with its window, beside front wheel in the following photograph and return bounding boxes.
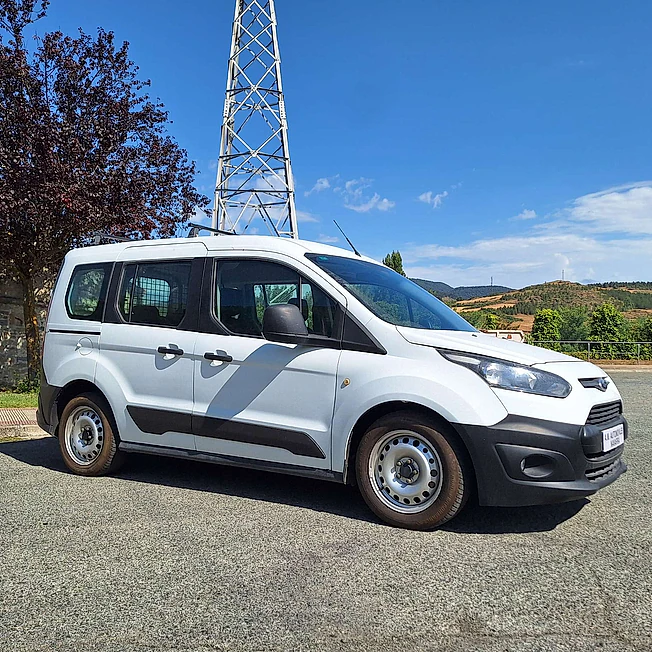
[193,258,340,469]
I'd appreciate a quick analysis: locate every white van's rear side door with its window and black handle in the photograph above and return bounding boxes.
[97,244,206,450]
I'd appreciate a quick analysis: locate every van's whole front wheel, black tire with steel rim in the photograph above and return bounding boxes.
[356,410,473,530]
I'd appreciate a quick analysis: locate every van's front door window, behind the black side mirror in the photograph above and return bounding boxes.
[215,260,337,337]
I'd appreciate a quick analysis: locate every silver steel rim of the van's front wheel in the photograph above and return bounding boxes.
[368,430,442,514]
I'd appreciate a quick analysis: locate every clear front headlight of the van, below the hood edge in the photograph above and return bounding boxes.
[437,349,571,398]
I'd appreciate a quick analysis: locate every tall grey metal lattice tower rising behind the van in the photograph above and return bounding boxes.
[213,0,298,238]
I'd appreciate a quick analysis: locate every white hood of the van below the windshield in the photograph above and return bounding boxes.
[396,326,578,366]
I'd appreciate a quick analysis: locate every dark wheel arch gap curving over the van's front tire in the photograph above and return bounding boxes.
[343,401,477,491]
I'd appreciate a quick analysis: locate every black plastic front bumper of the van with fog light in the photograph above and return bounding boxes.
[453,415,628,507]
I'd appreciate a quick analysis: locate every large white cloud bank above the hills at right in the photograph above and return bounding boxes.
[401,182,652,287]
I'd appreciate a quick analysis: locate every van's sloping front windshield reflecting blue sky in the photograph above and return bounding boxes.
[306,254,475,331]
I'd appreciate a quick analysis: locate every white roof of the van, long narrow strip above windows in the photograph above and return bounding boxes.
[67,235,378,263]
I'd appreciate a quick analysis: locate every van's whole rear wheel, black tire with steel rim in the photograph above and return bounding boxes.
[59,392,124,476]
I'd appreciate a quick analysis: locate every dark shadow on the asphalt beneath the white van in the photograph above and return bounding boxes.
[0,437,589,534]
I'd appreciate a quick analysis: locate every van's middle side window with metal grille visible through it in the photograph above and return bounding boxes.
[118,261,192,326]
